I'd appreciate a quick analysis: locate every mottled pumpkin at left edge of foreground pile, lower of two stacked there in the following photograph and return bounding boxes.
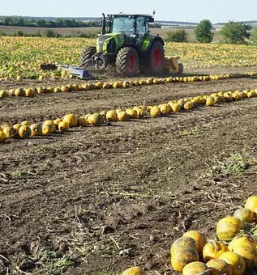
[171,248,199,272]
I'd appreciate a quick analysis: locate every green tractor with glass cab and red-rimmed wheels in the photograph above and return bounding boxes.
[81,13,164,77]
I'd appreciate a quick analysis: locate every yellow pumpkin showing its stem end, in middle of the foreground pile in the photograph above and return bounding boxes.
[203,241,228,262]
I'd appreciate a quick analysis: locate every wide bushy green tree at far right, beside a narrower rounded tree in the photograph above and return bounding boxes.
[221,21,252,44]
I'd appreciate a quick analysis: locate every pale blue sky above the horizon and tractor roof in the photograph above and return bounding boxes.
[0,0,257,24]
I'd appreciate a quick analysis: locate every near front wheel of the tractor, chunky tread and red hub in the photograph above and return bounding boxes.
[116,47,139,77]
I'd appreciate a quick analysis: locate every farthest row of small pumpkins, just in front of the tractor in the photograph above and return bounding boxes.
[0,73,257,98]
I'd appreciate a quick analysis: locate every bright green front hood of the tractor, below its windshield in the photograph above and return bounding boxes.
[97,33,125,54]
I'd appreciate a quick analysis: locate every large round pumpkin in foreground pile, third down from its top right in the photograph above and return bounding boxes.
[216,217,244,241]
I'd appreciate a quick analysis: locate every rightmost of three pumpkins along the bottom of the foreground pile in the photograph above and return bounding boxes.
[219,251,245,275]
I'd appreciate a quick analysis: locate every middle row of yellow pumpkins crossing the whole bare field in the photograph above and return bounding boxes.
[0,89,257,142]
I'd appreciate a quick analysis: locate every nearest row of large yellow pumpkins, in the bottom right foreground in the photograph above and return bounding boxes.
[122,196,257,275]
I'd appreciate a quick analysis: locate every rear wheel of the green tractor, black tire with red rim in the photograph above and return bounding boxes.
[147,40,164,75]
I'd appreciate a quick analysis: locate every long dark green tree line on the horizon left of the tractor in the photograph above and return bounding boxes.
[0,16,99,28]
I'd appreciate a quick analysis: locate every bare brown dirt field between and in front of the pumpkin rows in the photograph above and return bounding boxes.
[0,70,257,275]
